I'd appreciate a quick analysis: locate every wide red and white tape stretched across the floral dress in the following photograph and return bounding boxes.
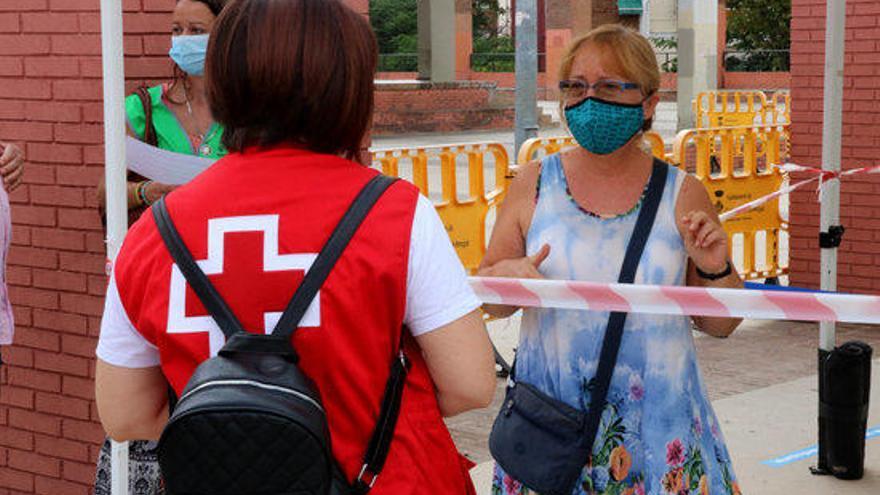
[470,277,880,324]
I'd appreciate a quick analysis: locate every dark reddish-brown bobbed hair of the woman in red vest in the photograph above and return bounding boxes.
[205,0,378,159]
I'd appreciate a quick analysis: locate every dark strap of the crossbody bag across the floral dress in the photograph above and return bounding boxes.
[585,159,669,457]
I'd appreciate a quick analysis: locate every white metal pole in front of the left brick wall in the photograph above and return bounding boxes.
[101,0,128,495]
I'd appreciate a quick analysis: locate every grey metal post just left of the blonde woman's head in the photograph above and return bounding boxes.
[514,0,538,155]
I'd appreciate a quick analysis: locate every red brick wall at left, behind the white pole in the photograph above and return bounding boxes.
[0,0,180,495]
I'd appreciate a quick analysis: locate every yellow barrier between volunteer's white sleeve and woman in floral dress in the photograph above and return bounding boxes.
[373,143,510,273]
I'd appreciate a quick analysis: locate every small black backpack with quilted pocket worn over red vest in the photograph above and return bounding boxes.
[153,175,408,495]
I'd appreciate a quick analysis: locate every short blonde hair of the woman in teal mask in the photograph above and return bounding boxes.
[559,24,660,131]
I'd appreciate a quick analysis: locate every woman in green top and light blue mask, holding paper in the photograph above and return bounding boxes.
[95,0,227,495]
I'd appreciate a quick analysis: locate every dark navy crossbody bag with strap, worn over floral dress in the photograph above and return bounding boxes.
[489,160,669,495]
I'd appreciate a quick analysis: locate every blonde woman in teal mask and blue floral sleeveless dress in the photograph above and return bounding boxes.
[480,25,742,495]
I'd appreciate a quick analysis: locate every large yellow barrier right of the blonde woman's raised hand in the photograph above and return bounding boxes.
[673,124,788,279]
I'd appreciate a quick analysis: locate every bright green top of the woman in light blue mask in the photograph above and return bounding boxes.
[125,85,227,160]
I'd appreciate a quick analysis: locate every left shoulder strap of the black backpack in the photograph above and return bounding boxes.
[153,197,244,340]
